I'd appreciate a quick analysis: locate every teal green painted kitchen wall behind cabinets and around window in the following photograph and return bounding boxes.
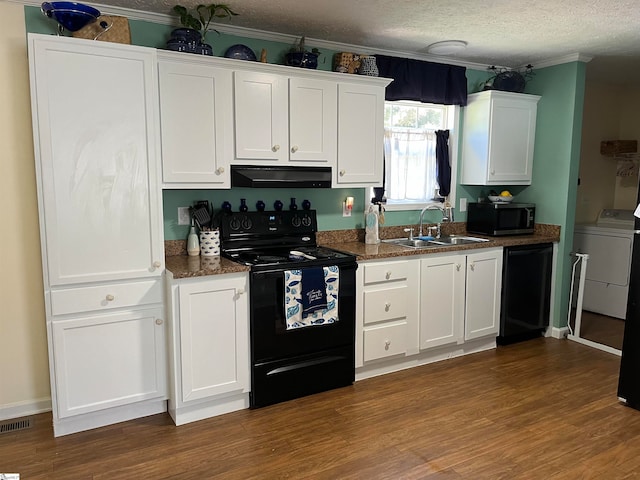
[25,6,585,326]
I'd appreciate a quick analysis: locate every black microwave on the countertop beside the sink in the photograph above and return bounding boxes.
[467,202,536,236]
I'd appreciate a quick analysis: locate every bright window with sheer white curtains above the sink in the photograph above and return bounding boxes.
[384,101,457,210]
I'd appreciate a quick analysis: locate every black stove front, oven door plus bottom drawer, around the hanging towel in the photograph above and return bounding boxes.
[250,263,357,408]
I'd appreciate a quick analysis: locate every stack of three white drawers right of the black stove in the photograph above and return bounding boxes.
[356,260,419,367]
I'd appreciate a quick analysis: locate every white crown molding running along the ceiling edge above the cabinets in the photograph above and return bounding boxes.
[15,0,593,70]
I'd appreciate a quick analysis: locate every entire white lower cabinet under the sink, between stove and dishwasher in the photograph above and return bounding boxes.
[356,248,502,380]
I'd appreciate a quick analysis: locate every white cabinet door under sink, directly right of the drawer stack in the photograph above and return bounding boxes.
[420,255,465,349]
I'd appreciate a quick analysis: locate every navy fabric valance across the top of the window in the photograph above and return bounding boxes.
[376,55,467,106]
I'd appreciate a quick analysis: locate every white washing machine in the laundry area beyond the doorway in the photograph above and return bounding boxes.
[573,209,634,320]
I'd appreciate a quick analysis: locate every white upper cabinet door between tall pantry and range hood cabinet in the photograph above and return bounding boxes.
[158,60,233,188]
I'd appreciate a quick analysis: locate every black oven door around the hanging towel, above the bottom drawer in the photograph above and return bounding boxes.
[250,264,357,364]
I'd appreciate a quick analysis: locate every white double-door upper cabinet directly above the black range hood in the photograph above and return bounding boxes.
[234,71,337,165]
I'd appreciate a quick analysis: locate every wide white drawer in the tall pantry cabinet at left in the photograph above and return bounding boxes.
[51,280,162,315]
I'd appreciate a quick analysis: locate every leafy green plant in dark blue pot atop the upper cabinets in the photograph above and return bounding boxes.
[167,3,238,55]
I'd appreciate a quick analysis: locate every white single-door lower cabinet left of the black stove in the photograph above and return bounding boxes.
[169,273,250,425]
